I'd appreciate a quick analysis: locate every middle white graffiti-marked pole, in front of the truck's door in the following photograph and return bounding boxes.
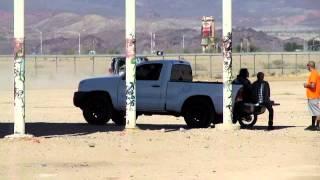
[126,0,136,129]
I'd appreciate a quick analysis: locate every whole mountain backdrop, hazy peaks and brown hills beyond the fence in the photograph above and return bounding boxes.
[0,0,320,53]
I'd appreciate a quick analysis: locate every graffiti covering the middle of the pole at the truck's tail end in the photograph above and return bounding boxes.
[223,32,232,110]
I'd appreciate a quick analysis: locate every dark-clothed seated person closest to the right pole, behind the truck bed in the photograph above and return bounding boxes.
[232,68,251,123]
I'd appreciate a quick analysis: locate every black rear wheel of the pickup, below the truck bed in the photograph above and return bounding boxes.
[183,98,215,128]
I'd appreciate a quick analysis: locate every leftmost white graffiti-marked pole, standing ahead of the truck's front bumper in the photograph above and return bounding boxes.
[8,0,30,138]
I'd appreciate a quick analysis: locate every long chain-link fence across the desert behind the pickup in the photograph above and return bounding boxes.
[0,52,320,88]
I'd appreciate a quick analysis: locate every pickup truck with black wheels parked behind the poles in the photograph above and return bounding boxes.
[73,60,241,128]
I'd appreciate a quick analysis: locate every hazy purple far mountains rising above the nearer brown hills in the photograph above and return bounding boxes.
[0,0,320,27]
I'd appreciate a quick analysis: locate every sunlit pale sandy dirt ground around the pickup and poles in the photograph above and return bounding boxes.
[0,77,320,180]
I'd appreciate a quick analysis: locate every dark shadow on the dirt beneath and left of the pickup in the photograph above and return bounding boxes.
[0,122,187,138]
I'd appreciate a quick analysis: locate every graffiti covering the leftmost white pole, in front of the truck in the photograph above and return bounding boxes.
[14,38,25,118]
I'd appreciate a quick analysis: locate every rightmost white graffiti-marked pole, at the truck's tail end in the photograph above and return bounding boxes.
[222,0,236,129]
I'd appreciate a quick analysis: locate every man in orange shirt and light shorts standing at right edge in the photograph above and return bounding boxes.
[304,61,320,130]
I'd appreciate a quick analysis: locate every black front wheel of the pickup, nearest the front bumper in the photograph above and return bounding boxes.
[82,95,112,125]
